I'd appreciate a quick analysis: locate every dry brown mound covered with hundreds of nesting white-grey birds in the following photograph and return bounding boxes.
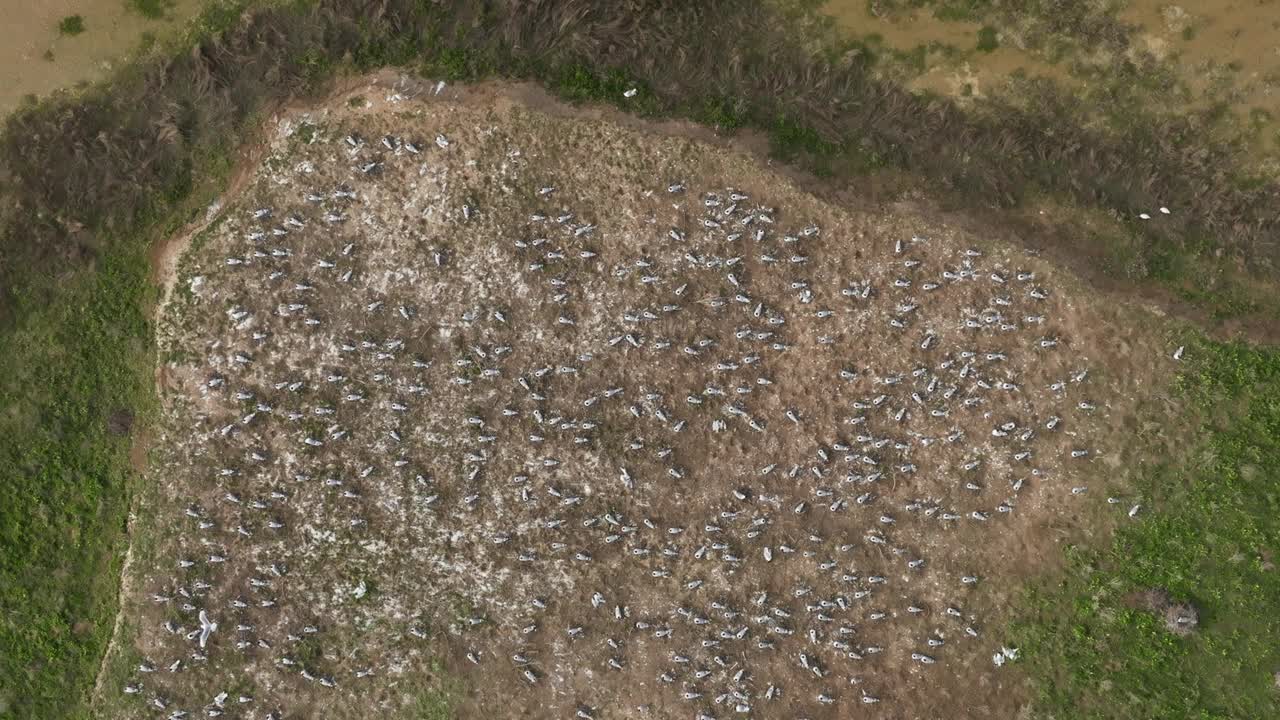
[124,100,1146,720]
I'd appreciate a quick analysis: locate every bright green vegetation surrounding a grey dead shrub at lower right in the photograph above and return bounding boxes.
[1015,341,1280,720]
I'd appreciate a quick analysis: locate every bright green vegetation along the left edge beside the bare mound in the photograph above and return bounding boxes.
[0,245,154,717]
